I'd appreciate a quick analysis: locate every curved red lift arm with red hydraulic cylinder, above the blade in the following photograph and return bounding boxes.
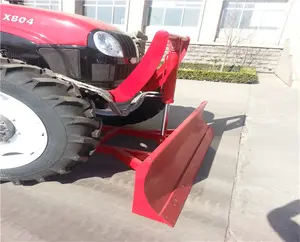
[110,31,190,103]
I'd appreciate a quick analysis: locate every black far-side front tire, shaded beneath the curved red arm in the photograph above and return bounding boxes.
[97,97,165,126]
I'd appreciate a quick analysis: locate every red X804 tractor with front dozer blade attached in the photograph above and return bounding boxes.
[0,4,213,226]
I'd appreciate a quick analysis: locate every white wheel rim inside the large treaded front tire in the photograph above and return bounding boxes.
[0,92,48,169]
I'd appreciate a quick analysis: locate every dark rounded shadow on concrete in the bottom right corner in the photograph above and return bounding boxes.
[267,199,300,242]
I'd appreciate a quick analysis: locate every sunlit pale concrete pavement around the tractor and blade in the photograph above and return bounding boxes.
[0,75,300,242]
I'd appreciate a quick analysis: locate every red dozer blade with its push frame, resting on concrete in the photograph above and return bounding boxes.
[98,102,213,227]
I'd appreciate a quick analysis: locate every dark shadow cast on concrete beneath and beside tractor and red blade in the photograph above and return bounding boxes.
[12,106,245,185]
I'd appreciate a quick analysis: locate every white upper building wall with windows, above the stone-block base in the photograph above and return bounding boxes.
[64,0,294,46]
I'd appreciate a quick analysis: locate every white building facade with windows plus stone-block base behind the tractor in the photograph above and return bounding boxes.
[2,0,300,71]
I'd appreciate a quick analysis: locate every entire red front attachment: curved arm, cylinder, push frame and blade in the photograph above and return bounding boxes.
[96,31,213,227]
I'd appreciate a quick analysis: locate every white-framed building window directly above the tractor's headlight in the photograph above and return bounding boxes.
[84,0,127,25]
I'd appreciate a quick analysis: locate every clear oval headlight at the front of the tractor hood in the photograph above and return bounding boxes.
[94,31,123,57]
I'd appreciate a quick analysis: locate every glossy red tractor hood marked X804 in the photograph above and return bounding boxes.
[0,4,121,46]
